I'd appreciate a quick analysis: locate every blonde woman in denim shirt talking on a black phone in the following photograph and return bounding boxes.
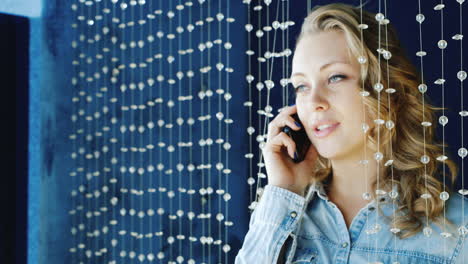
[236,4,468,264]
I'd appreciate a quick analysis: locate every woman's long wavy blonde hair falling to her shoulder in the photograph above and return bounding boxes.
[297,4,457,239]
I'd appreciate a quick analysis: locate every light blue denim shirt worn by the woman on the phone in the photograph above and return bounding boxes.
[235,182,468,264]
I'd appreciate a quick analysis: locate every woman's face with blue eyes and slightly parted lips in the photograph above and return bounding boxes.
[291,31,372,160]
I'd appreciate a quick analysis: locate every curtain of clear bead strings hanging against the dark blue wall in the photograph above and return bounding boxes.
[33,0,466,263]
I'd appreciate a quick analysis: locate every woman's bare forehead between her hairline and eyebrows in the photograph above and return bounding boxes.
[292,30,352,72]
